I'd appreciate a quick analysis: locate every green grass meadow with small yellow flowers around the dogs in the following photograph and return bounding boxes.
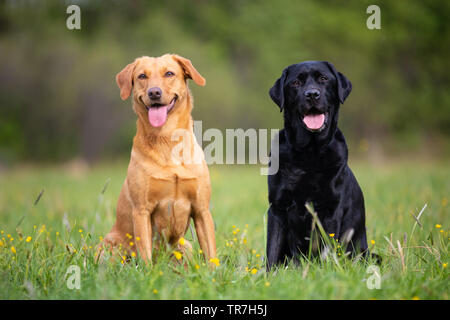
[0,162,450,299]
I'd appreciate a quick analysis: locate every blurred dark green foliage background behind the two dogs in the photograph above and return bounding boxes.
[0,0,450,166]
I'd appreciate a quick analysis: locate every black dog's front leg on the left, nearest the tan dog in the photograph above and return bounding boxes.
[266,207,289,271]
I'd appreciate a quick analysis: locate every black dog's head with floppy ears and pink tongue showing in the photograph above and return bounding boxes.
[269,61,352,144]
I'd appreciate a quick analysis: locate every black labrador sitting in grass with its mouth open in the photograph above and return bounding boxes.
[267,61,367,269]
